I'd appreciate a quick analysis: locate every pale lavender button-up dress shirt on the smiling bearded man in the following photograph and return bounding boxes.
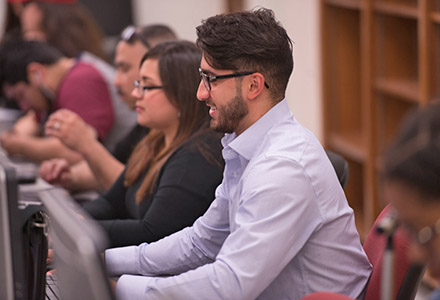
[106,100,371,300]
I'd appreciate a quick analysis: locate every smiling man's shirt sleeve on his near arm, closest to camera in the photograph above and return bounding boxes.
[107,158,321,299]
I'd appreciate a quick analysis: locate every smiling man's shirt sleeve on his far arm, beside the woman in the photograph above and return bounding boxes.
[106,182,229,276]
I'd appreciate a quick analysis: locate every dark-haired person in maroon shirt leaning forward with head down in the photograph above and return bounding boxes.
[0,39,114,163]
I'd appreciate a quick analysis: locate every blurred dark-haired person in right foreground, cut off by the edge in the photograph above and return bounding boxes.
[382,102,440,300]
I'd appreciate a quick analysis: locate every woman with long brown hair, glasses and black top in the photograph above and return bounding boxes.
[85,41,223,247]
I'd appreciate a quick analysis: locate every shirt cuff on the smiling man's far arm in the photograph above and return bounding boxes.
[105,246,139,276]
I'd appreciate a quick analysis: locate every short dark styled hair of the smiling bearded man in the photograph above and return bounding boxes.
[196,8,293,101]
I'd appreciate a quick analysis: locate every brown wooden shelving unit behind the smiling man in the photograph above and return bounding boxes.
[321,0,440,237]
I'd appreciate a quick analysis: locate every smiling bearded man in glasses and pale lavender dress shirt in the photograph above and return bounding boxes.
[105,8,371,299]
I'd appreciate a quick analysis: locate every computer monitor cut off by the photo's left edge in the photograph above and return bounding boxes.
[0,162,28,300]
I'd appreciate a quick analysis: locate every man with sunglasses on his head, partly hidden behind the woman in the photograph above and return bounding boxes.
[40,24,177,191]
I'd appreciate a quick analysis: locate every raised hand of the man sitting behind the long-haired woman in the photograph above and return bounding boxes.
[45,109,98,153]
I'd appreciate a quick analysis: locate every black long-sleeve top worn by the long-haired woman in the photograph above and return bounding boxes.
[84,131,224,247]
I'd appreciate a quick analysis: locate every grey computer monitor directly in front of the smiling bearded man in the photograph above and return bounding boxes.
[38,188,114,300]
